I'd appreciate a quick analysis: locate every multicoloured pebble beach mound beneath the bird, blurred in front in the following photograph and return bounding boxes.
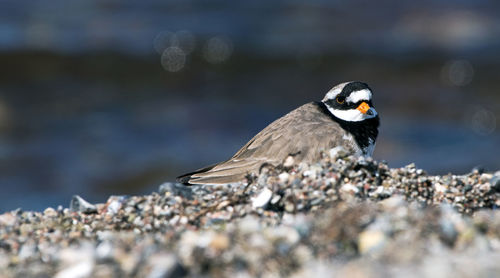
[0,150,500,277]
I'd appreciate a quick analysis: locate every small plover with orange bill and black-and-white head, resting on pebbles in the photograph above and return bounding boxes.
[177,81,380,185]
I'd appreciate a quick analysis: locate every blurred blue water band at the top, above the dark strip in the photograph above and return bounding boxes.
[0,0,500,55]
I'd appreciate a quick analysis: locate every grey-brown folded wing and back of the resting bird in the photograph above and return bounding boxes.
[177,102,351,184]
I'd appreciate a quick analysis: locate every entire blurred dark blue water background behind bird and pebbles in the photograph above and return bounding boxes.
[0,0,500,212]
